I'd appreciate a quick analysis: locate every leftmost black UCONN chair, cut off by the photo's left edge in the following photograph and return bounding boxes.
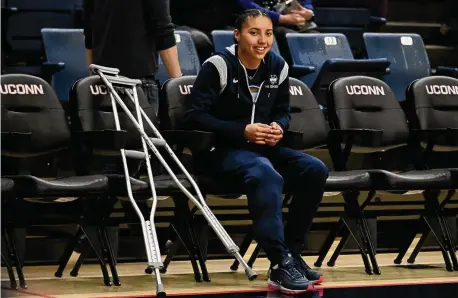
[1,75,109,288]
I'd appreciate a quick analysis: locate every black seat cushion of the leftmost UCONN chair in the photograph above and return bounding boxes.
[5,175,109,197]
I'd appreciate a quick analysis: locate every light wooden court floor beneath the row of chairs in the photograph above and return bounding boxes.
[1,240,458,298]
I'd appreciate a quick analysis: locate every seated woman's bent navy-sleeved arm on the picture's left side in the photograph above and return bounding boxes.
[185,62,246,140]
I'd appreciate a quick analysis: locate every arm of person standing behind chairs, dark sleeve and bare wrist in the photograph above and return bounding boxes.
[143,0,181,78]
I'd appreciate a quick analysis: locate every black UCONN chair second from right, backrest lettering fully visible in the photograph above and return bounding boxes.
[322,76,457,271]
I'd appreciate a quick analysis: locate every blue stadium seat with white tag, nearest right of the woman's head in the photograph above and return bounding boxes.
[286,33,353,88]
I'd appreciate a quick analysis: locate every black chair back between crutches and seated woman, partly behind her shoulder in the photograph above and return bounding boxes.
[159,76,197,130]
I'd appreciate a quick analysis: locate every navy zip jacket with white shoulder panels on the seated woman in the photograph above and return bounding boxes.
[185,45,291,148]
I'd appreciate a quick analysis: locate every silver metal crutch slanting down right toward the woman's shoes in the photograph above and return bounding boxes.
[90,64,257,288]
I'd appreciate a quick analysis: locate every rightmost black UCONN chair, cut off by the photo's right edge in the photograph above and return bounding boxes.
[394,76,458,270]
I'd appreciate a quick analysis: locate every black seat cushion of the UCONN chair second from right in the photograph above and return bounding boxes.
[369,170,452,190]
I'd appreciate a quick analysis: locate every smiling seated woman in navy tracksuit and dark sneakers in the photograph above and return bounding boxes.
[185,9,328,293]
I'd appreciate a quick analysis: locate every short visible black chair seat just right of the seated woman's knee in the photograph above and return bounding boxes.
[325,171,371,191]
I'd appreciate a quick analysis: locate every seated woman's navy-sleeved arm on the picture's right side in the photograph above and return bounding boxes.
[272,62,291,133]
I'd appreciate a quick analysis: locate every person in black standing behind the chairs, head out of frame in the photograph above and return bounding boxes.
[84,0,181,115]
